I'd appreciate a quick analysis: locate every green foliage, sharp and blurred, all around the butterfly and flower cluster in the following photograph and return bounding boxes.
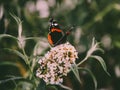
[0,0,120,90]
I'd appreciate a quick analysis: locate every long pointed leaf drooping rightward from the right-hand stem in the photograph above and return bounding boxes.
[90,55,111,76]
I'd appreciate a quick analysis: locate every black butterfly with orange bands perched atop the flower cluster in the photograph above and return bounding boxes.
[47,18,73,47]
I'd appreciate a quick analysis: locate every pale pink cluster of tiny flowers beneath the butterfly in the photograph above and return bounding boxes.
[36,42,78,84]
